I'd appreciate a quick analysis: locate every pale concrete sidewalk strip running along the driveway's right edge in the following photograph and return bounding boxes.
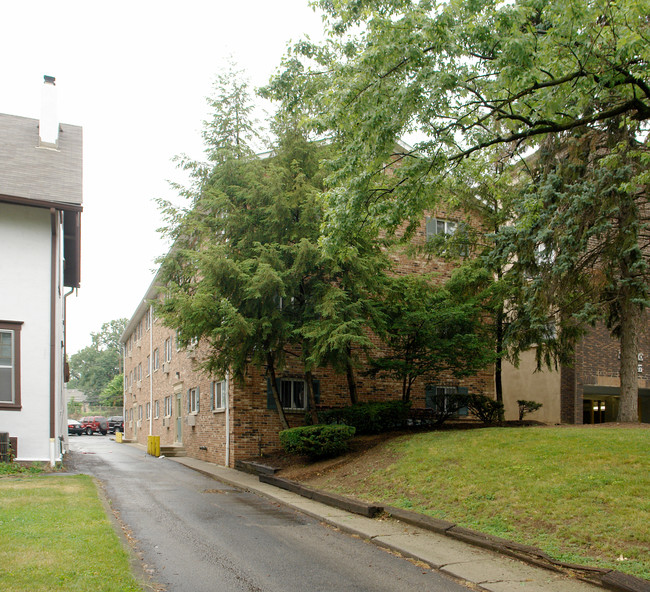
[167,457,612,592]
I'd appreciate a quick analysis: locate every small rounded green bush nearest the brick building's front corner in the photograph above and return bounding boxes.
[280,424,355,458]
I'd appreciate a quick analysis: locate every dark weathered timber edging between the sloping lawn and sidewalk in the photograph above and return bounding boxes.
[246,466,650,592]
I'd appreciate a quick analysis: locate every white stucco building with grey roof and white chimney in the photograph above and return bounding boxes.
[0,76,82,464]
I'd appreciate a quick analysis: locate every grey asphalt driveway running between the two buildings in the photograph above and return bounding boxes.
[69,436,468,592]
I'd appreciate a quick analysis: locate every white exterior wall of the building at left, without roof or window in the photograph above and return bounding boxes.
[0,203,67,461]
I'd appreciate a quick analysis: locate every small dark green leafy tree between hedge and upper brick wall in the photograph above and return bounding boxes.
[370,275,493,402]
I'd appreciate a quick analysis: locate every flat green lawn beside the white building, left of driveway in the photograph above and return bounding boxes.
[0,474,141,592]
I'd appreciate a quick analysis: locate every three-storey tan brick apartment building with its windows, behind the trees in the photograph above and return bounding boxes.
[121,211,494,466]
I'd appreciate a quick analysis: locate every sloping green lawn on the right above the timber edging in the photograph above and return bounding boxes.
[312,427,650,579]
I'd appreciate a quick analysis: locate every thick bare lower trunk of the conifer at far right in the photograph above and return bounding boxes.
[616,294,641,423]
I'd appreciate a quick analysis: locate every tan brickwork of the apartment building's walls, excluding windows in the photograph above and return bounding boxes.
[124,212,494,465]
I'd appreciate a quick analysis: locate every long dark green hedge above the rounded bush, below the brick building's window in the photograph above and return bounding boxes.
[318,401,411,435]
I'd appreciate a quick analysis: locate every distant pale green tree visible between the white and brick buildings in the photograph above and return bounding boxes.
[68,319,128,405]
